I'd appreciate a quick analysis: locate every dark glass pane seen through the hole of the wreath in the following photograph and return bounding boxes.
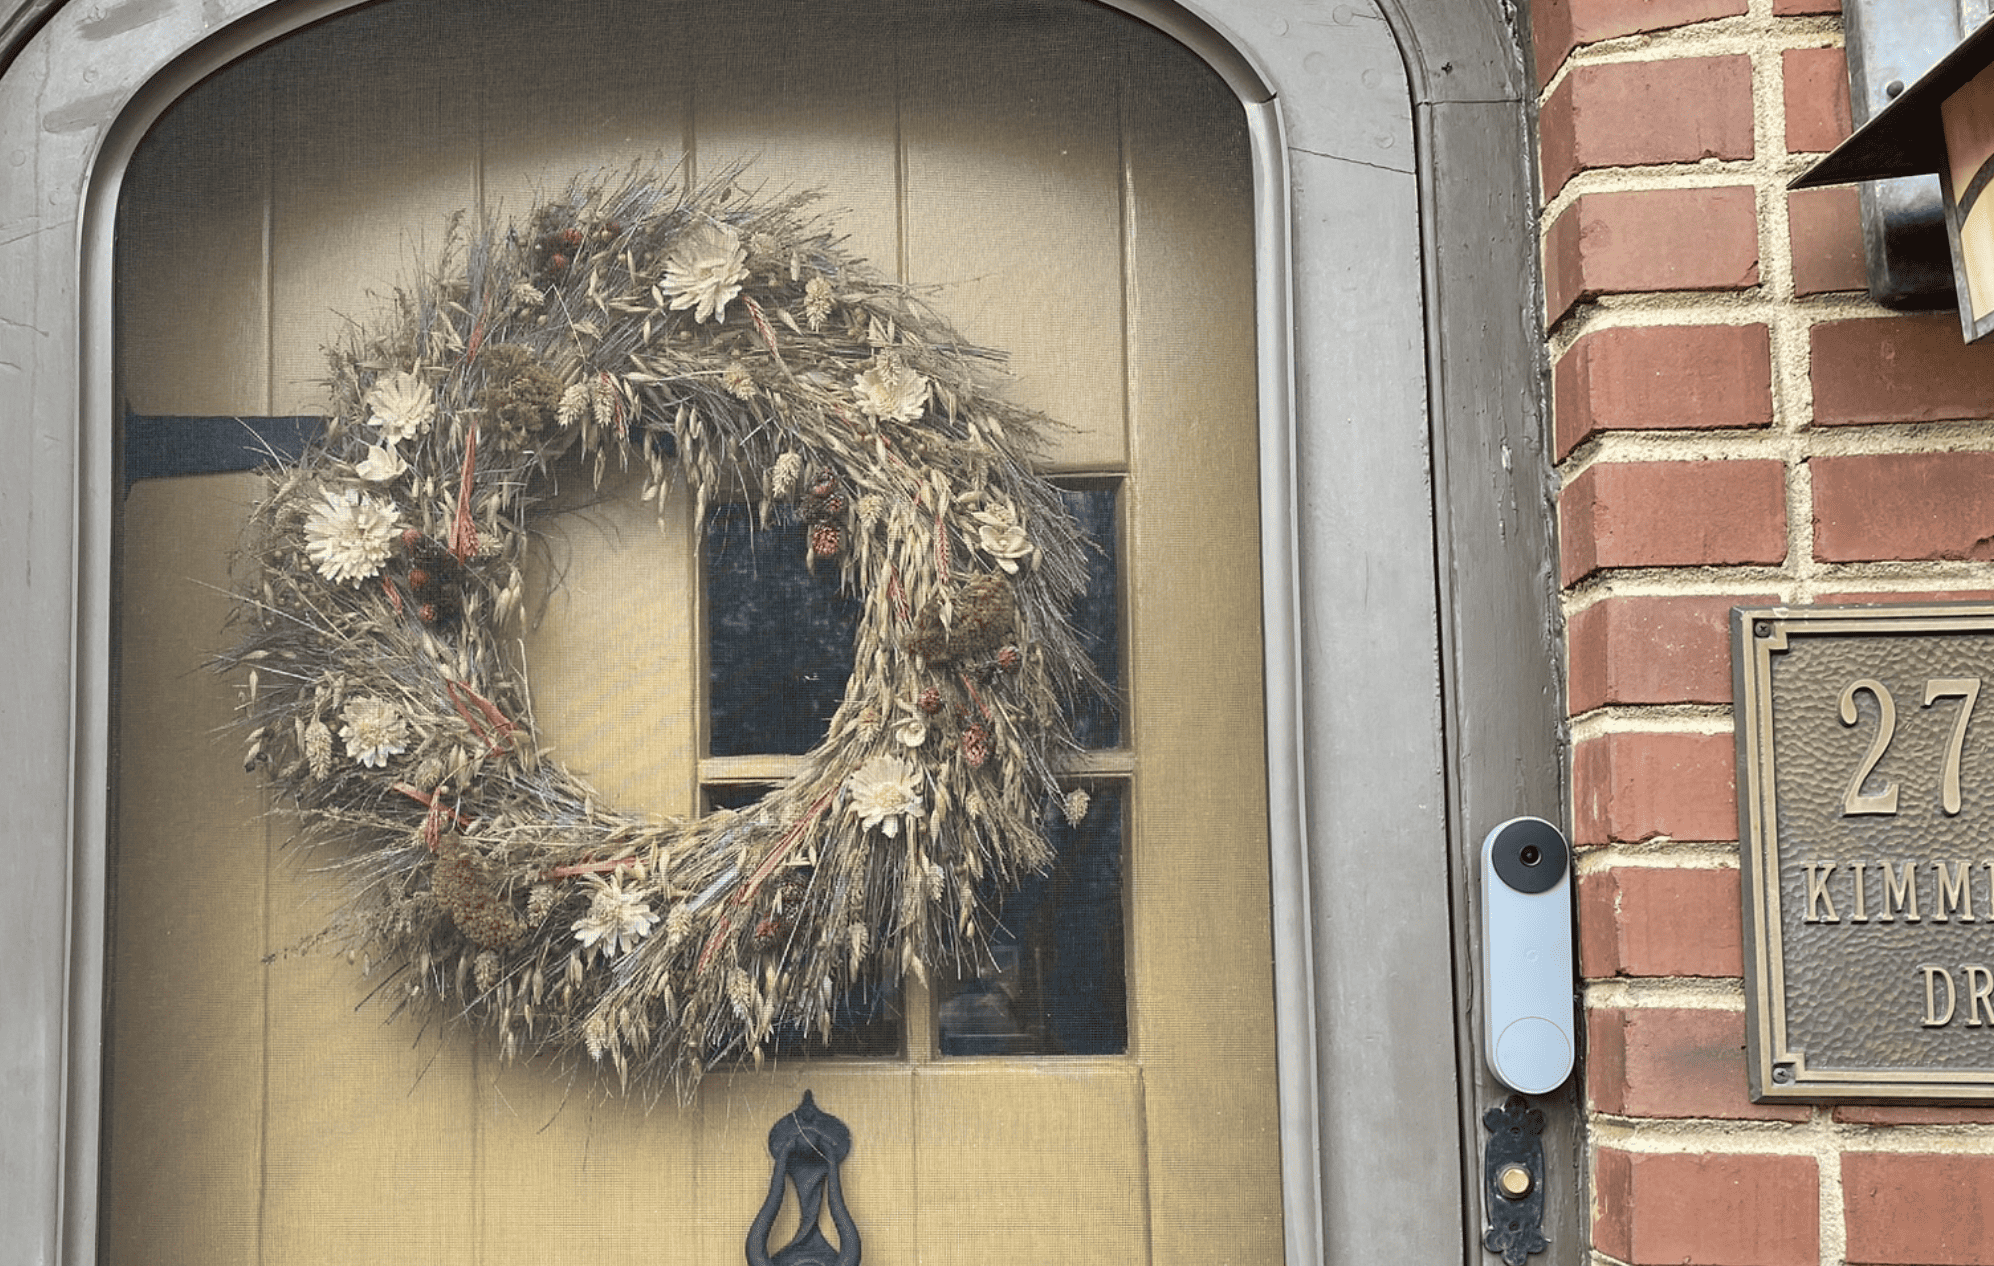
[706,504,859,756]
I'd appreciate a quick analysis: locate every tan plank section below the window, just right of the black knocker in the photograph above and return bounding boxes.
[913,1061,1148,1266]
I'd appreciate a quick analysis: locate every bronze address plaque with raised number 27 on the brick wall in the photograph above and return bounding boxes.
[1731,604,1994,1101]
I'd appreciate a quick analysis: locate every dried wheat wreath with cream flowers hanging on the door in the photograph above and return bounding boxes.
[233,173,1101,1093]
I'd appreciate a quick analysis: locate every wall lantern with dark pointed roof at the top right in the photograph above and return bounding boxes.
[1791,24,1994,343]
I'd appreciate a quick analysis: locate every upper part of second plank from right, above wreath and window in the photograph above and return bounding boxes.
[901,0,1127,471]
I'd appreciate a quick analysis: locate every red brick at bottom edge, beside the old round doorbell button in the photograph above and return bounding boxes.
[1593,1146,1821,1266]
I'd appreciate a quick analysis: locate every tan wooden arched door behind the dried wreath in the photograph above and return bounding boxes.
[104,0,1282,1266]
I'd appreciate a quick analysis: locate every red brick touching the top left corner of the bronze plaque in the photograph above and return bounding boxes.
[1565,594,1779,716]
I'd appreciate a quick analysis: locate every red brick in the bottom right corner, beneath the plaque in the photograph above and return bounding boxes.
[1842,1152,1994,1266]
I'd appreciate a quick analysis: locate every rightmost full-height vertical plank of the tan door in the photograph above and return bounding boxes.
[1129,42,1282,1264]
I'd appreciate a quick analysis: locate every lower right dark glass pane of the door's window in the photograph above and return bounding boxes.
[937,784,1129,1055]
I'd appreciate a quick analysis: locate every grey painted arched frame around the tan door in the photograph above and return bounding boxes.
[0,0,1555,1264]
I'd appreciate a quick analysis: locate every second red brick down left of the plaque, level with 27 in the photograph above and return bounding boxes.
[1571,734,1739,845]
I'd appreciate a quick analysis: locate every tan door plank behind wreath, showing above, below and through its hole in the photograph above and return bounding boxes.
[463,0,700,1266]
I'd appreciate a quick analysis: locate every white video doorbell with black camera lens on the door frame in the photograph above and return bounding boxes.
[1482,817,1577,1095]
